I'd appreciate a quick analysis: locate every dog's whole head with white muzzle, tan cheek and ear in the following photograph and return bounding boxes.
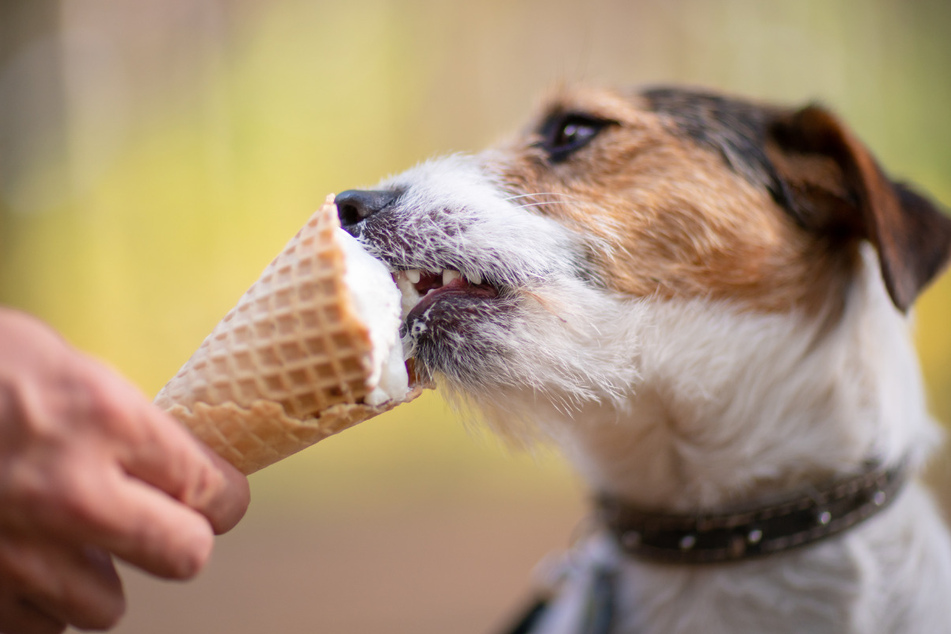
[337,81,951,422]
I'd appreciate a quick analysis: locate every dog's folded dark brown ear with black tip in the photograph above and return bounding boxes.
[766,106,951,311]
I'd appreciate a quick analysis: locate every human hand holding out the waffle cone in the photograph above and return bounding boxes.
[0,308,250,634]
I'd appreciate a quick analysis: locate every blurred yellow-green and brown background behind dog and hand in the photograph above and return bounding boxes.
[0,0,951,634]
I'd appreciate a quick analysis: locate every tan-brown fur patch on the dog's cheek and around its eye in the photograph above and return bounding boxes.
[490,88,857,313]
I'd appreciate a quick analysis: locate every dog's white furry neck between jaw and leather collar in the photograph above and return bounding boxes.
[551,249,936,511]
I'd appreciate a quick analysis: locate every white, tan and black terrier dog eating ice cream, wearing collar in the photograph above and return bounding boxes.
[337,86,951,634]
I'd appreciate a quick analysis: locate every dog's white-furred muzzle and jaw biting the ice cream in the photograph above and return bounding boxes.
[351,156,652,434]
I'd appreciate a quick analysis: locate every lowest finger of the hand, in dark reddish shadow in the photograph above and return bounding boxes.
[0,533,125,629]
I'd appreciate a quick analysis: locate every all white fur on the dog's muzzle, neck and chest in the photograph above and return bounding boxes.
[350,118,951,634]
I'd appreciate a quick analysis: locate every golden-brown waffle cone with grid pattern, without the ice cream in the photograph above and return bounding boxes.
[155,197,419,474]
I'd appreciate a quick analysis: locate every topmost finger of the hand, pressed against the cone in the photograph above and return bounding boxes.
[77,360,250,532]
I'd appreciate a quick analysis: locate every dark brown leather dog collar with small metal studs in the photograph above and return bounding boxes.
[597,464,905,564]
